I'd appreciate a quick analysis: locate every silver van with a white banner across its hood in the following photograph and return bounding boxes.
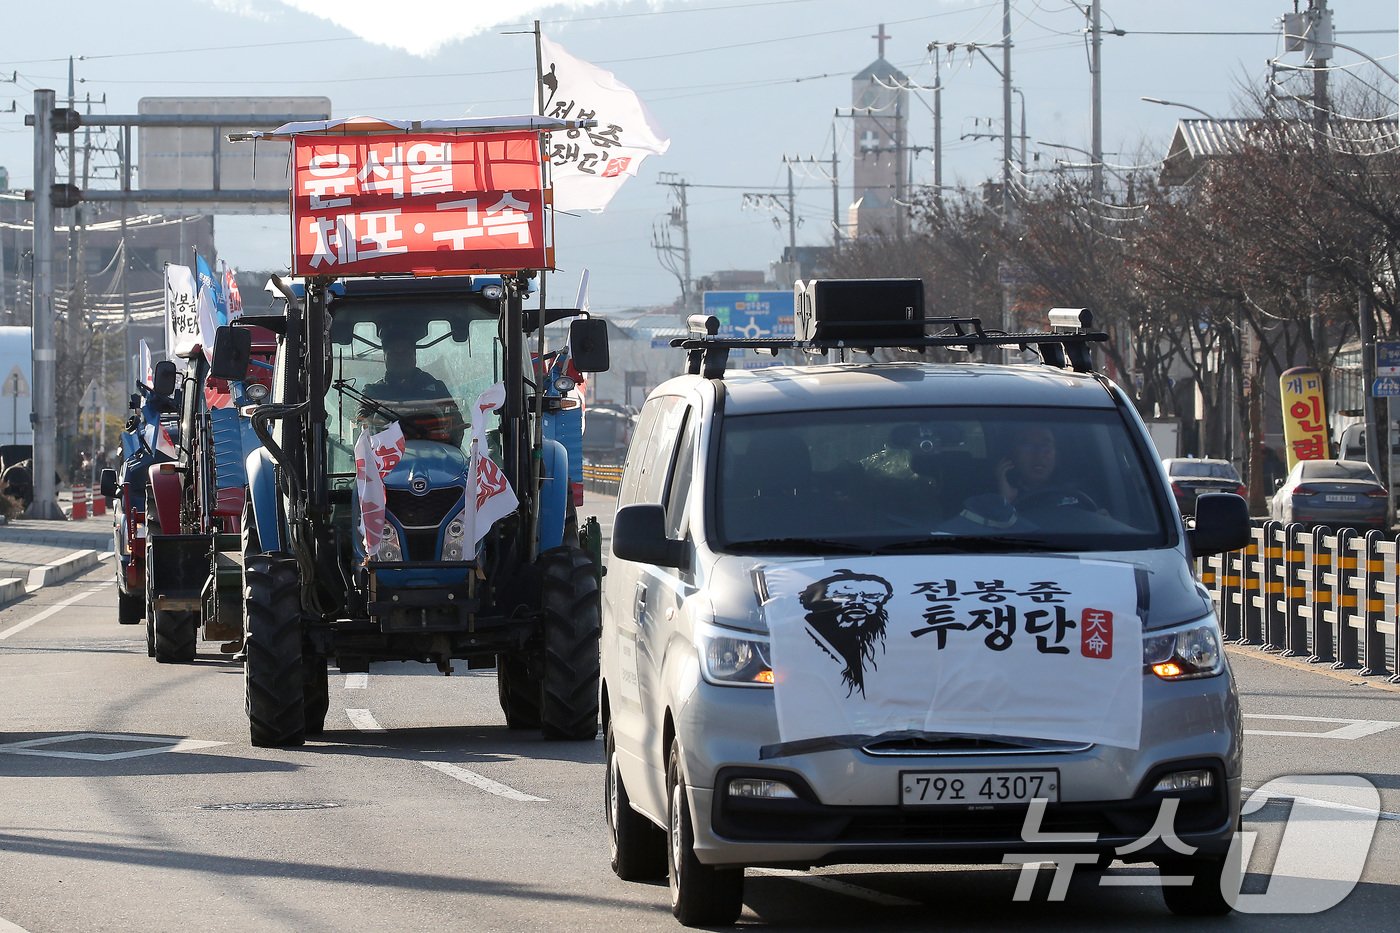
[601,288,1249,926]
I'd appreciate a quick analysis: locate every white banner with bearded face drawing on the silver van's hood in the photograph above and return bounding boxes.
[763,555,1142,748]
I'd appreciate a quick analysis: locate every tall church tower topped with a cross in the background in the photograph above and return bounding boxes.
[851,24,909,237]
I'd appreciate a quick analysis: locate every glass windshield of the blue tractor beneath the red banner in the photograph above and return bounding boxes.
[326,300,503,474]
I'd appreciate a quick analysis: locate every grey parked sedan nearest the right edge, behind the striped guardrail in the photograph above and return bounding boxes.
[1268,459,1390,531]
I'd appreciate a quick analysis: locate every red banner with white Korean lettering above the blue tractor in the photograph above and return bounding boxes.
[291,132,552,276]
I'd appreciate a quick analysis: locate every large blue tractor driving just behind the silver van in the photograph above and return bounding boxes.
[214,275,608,747]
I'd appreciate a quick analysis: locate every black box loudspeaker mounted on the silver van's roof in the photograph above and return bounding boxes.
[792,279,924,346]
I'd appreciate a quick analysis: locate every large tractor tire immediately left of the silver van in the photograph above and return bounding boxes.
[539,545,601,741]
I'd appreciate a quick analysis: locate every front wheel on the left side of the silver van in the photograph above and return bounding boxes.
[666,740,743,926]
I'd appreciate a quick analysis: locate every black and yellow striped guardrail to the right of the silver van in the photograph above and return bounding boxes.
[1198,521,1400,684]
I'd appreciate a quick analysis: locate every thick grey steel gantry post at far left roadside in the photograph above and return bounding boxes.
[28,88,63,520]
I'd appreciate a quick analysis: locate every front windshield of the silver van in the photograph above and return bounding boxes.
[713,406,1172,553]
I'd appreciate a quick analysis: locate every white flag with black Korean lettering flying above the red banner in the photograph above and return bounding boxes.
[539,36,671,210]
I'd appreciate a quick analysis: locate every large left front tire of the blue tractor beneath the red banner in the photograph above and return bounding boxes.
[244,553,307,748]
